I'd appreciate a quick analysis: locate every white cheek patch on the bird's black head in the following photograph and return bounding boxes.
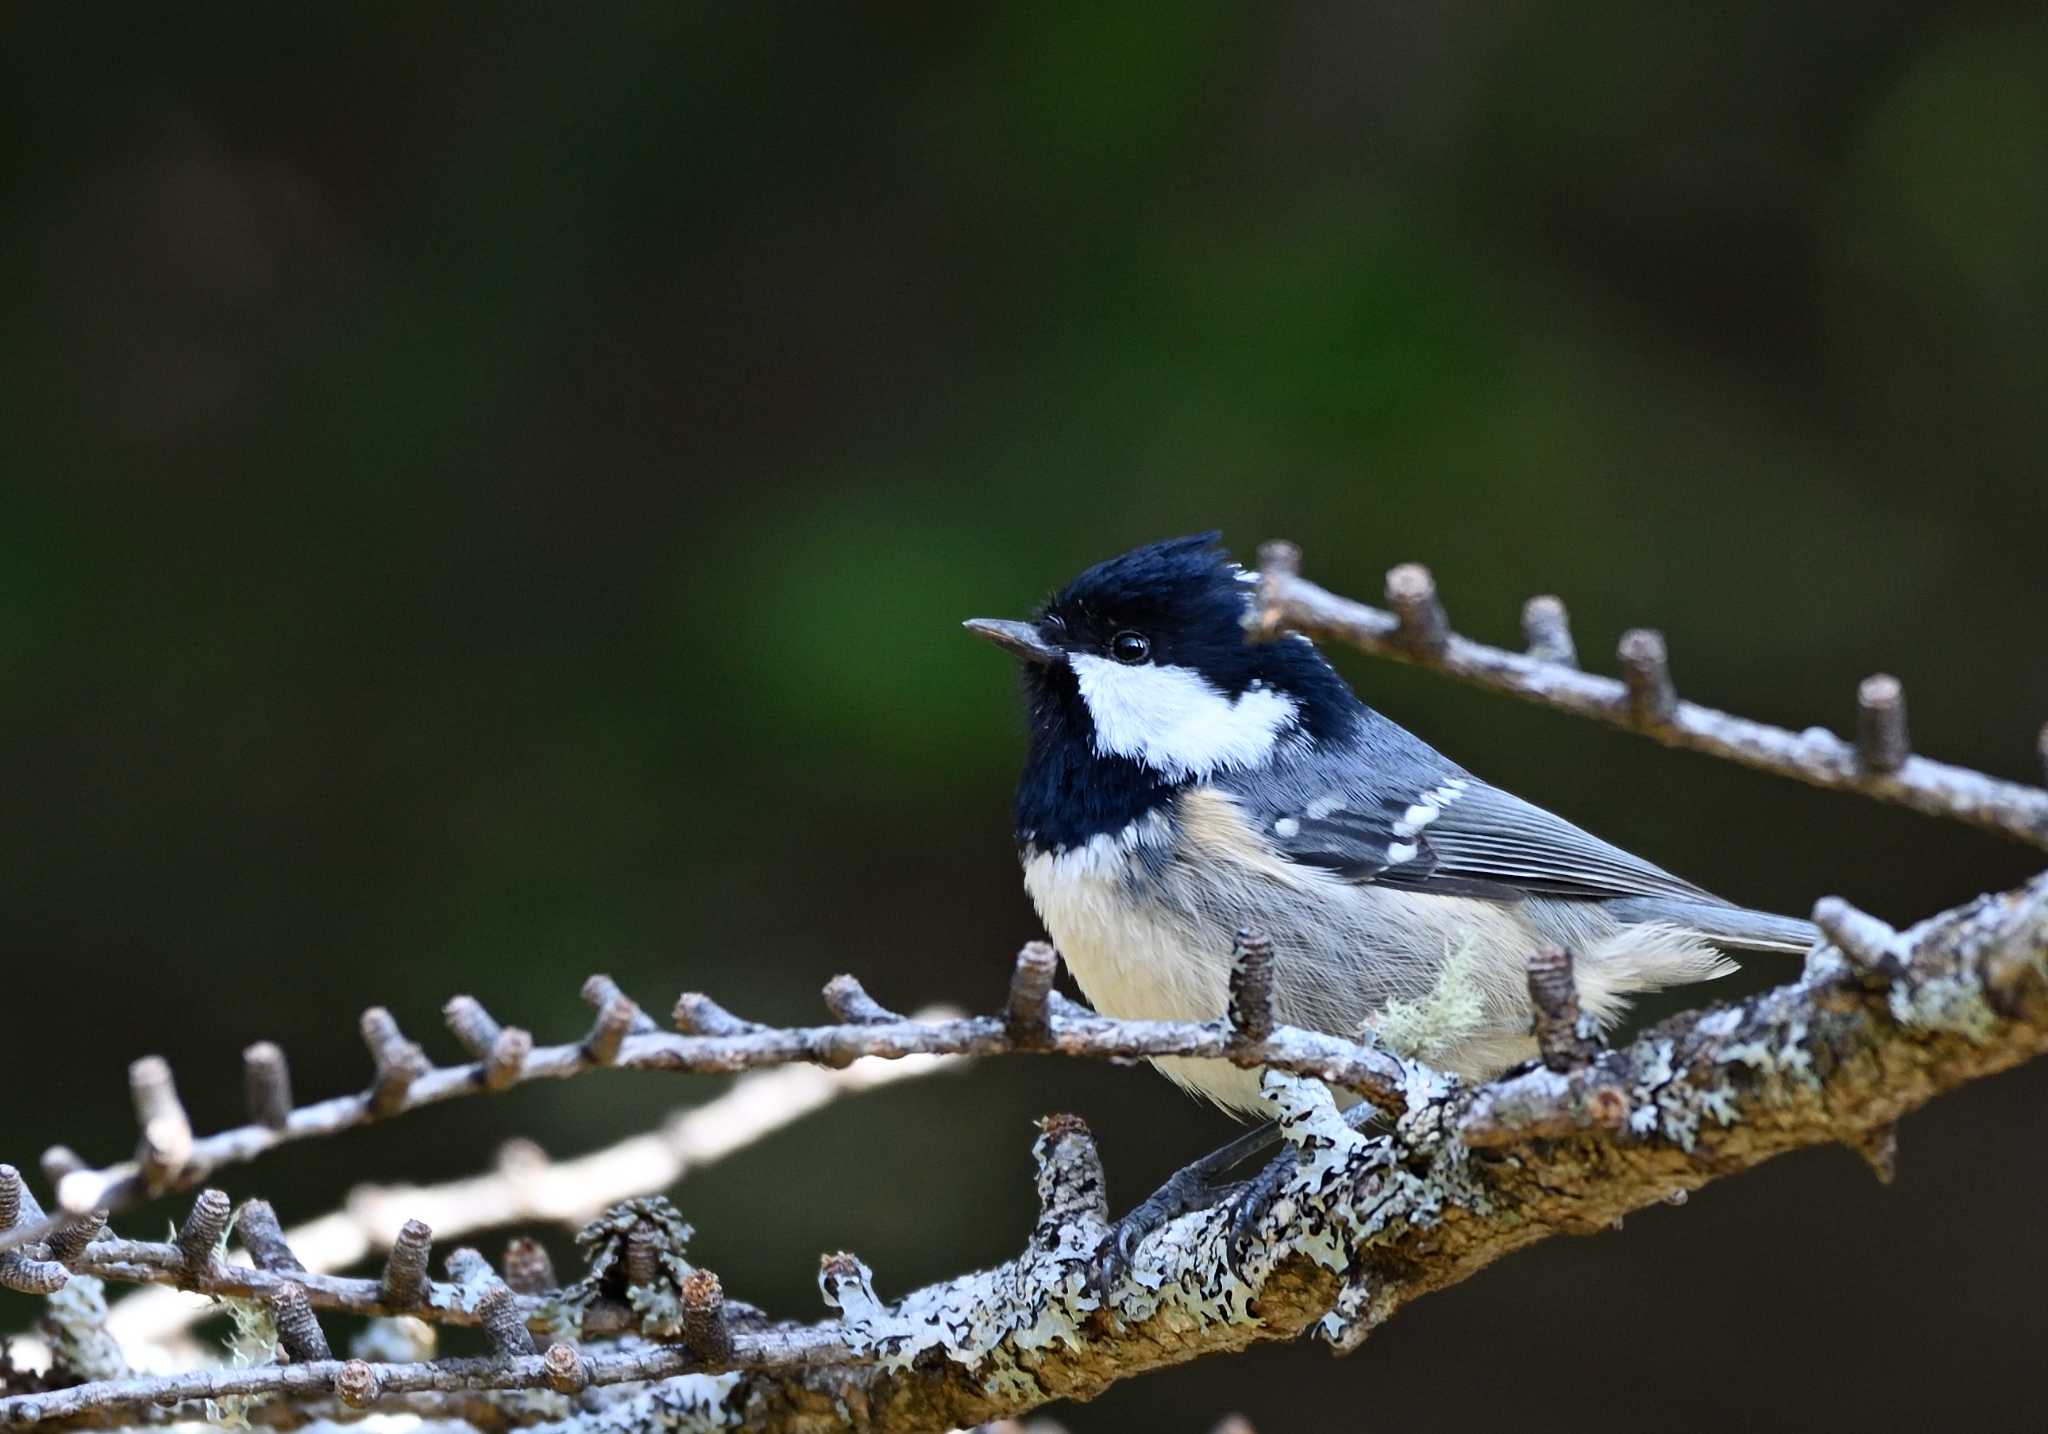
[1067,653,1298,778]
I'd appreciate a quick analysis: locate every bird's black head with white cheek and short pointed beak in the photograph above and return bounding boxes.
[967,533,1358,839]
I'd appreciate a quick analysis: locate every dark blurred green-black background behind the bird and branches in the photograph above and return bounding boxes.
[0,0,2048,1430]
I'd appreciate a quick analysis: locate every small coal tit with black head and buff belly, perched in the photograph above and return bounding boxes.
[967,533,1815,1112]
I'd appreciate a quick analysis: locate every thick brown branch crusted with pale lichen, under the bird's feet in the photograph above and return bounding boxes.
[16,875,2048,1430]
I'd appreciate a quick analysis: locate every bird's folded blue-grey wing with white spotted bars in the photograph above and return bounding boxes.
[1260,774,1718,905]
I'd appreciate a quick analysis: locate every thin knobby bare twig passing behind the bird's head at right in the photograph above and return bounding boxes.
[1251,543,2048,848]
